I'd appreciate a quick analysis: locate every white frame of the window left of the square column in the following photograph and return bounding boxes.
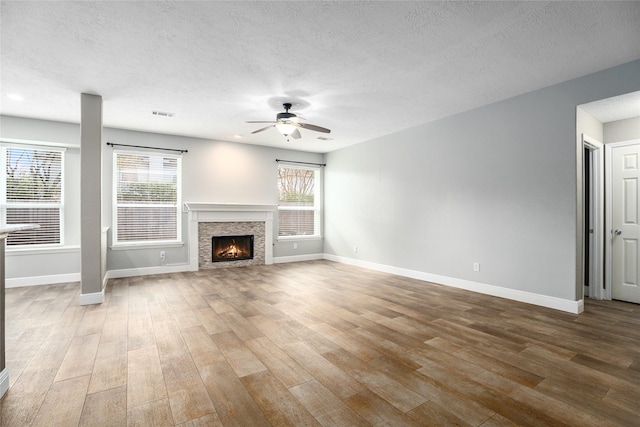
[0,141,67,252]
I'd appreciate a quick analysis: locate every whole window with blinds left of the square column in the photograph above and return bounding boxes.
[0,146,64,247]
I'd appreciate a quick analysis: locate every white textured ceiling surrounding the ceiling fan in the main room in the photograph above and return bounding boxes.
[0,1,640,152]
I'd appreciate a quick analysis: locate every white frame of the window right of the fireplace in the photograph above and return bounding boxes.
[276,162,324,241]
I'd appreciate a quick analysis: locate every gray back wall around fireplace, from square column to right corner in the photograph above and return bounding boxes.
[103,128,324,270]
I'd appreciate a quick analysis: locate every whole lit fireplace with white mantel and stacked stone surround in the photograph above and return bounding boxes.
[184,203,276,271]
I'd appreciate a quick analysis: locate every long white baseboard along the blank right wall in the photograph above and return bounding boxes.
[324,254,584,314]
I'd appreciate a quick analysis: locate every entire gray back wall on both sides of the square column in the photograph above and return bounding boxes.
[0,116,324,279]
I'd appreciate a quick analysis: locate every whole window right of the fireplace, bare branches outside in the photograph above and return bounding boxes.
[278,166,322,239]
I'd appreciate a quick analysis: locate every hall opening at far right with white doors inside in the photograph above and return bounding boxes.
[576,91,640,300]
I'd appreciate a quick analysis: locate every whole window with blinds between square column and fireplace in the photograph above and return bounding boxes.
[113,151,182,245]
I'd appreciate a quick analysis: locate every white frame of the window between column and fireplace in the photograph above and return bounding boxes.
[111,149,184,250]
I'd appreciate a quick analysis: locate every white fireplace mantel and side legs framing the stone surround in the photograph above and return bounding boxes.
[184,202,277,271]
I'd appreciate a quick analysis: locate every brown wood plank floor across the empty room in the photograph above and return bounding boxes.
[0,261,640,427]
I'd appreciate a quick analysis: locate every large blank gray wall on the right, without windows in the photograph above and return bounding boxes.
[325,61,640,301]
